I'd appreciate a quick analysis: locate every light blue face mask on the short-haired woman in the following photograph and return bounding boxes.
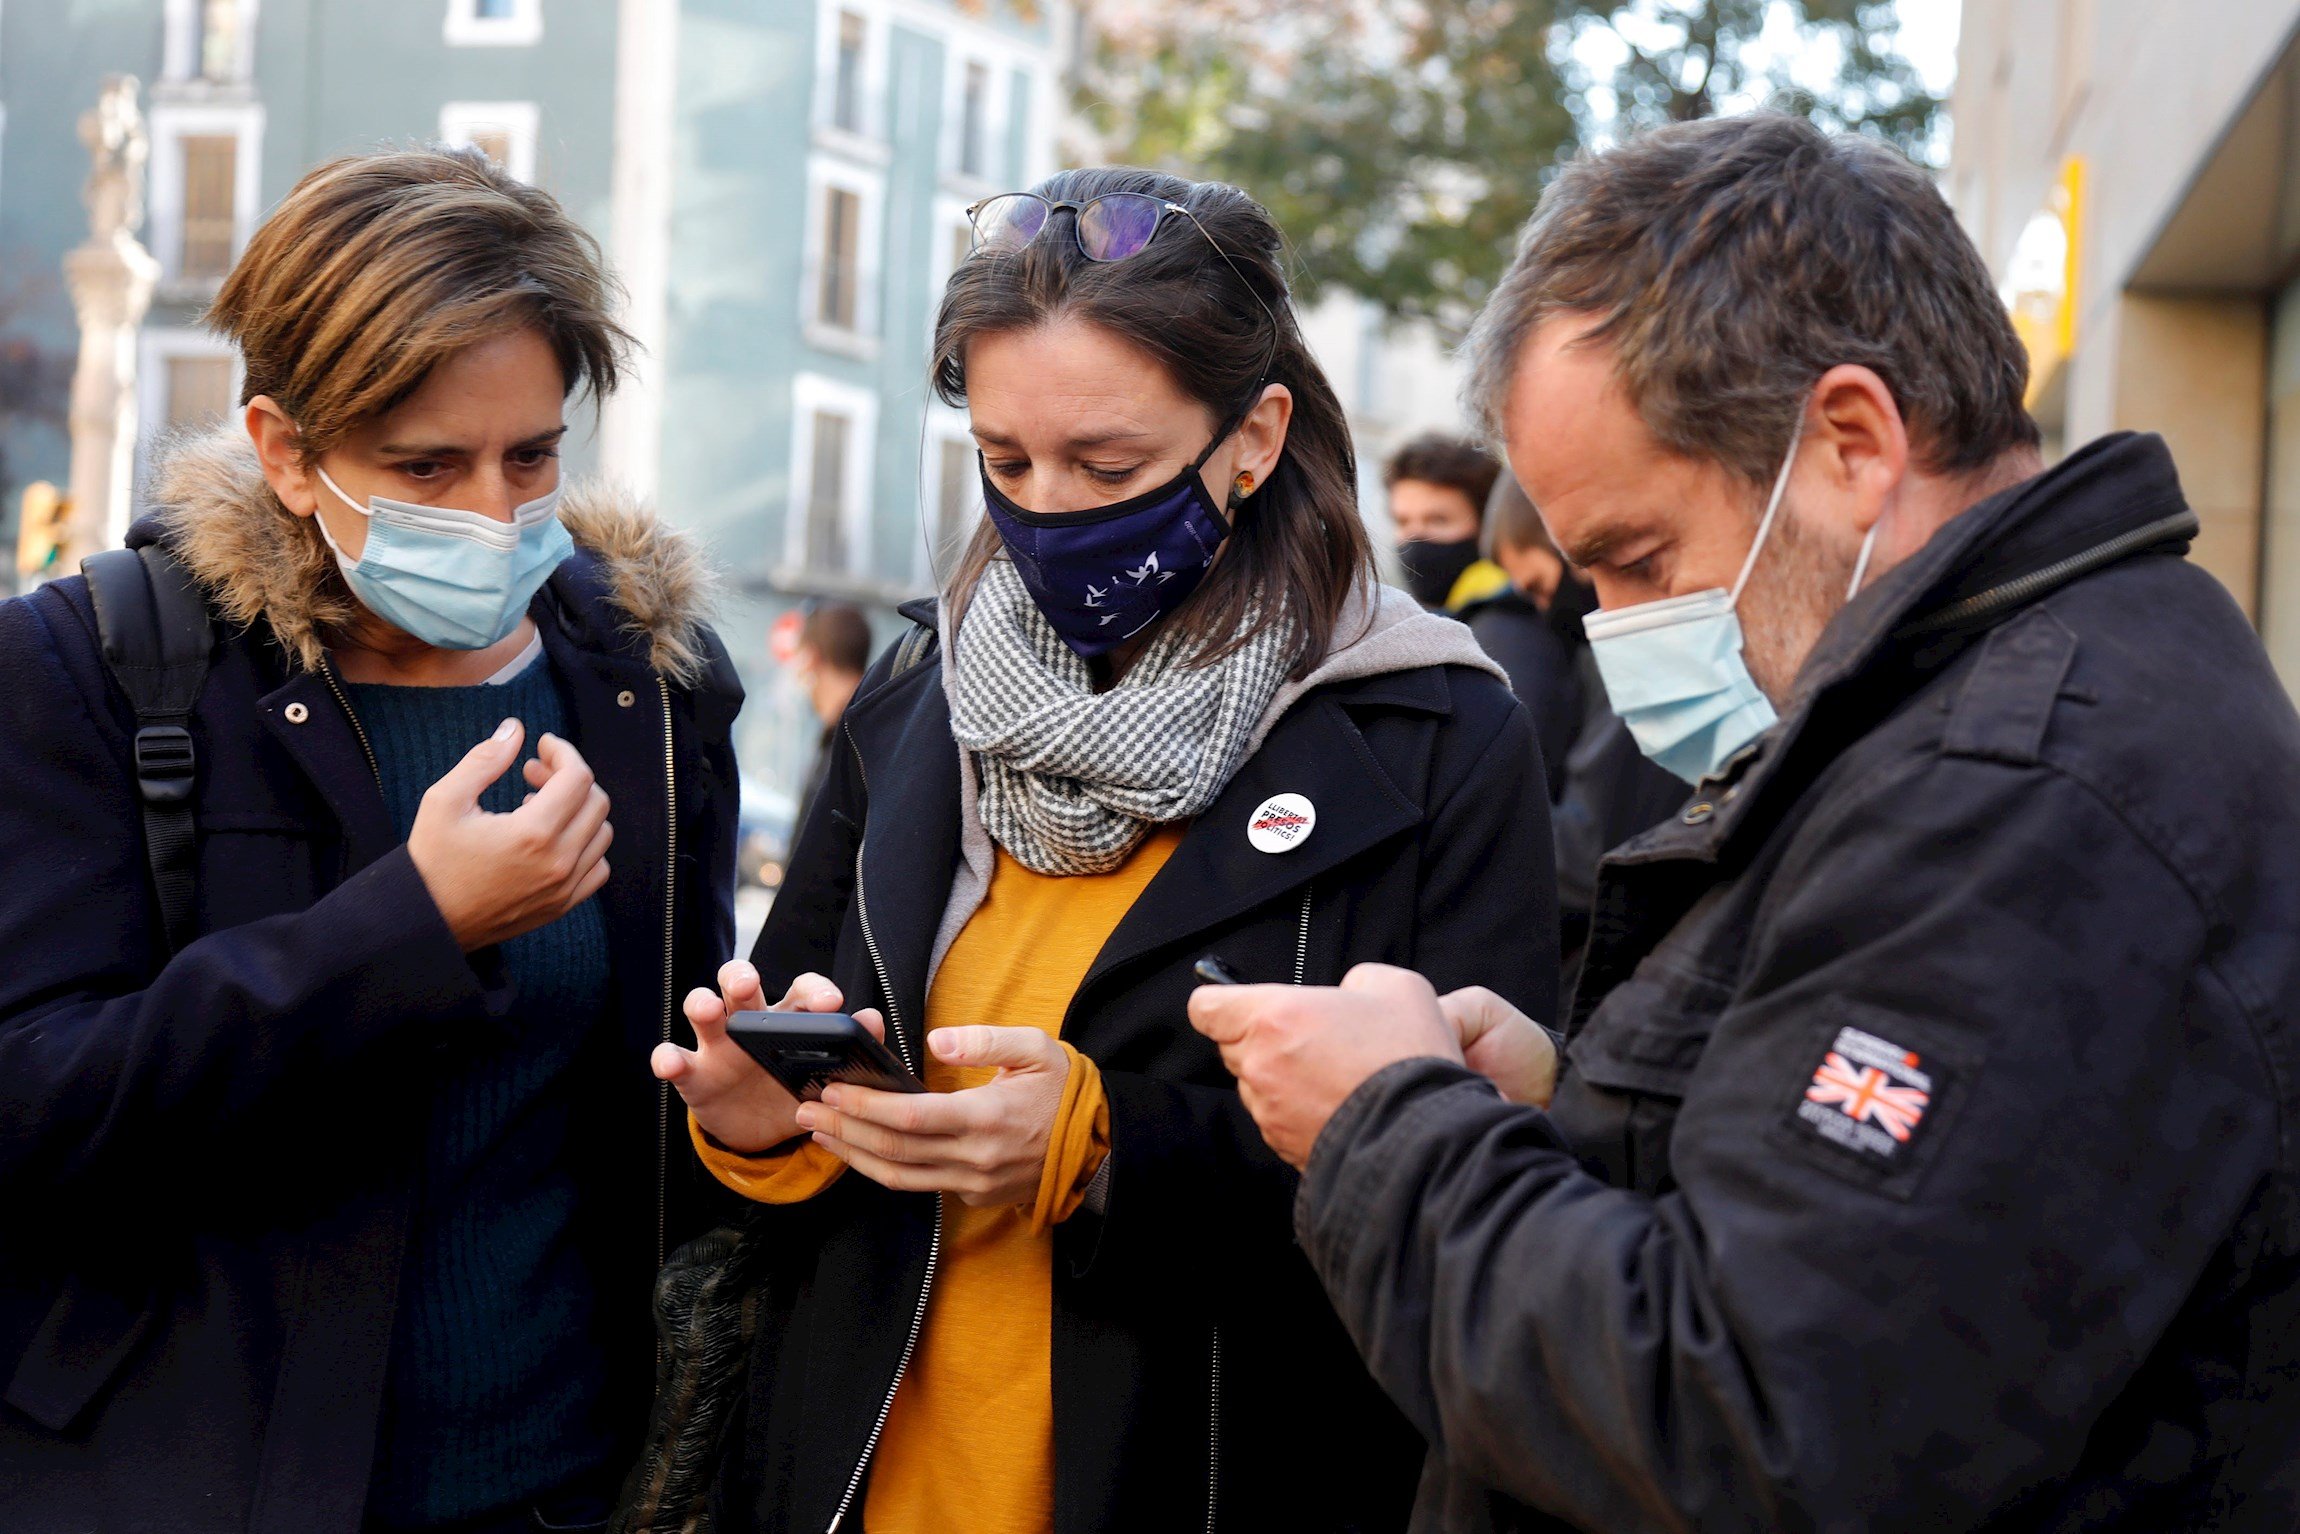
[317,469,575,651]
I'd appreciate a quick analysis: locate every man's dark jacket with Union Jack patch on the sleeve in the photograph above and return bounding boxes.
[1300,435,2300,1532]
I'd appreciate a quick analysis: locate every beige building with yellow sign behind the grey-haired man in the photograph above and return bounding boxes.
[1946,0,2300,690]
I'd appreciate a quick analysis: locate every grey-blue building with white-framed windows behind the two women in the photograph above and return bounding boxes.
[0,0,1070,800]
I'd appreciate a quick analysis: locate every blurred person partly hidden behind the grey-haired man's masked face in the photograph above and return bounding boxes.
[1463,469,1686,979]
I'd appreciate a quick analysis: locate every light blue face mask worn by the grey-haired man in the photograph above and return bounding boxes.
[1582,416,1877,784]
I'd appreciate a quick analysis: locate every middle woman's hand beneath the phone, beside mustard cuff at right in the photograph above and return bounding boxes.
[798,1023,1070,1207]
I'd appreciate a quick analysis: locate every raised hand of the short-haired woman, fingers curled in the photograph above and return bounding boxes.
[407,720,614,952]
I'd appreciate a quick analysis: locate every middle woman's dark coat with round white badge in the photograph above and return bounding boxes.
[720,607,1557,1534]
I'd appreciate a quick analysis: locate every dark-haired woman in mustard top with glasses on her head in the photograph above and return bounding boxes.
[656,170,1555,1534]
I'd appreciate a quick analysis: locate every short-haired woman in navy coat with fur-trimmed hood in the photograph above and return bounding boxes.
[0,152,743,1534]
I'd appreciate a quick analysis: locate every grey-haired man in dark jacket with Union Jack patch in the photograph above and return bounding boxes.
[1191,115,2300,1532]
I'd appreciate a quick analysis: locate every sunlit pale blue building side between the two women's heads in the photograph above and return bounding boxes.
[657,0,1070,809]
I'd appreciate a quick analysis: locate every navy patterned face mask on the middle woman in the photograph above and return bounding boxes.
[982,430,1231,660]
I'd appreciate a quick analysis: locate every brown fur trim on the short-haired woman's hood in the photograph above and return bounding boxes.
[152,425,718,685]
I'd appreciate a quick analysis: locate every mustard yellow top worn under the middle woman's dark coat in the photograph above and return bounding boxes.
[688,826,1182,1534]
